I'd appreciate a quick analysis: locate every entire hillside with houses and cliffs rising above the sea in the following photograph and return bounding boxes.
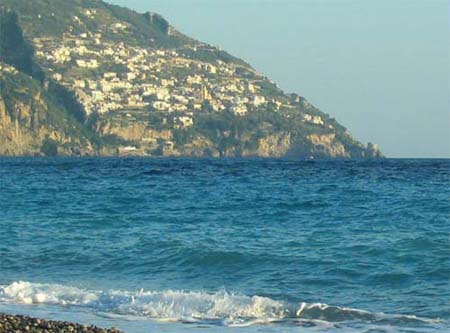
[0,0,381,158]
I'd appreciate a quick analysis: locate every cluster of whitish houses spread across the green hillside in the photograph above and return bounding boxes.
[30,10,323,132]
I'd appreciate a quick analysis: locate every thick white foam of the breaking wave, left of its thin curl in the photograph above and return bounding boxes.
[0,281,287,321]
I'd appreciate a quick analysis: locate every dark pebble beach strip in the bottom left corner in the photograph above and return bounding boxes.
[0,313,121,333]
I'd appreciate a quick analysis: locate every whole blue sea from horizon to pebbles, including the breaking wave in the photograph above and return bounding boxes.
[0,158,450,333]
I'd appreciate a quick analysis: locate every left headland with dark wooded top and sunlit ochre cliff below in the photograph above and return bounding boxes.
[0,9,92,155]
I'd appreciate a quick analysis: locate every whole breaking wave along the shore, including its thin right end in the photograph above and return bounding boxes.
[0,281,439,326]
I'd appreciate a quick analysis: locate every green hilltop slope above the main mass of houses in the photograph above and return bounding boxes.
[1,0,188,47]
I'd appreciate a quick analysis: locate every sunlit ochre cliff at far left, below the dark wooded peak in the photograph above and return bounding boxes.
[0,63,95,156]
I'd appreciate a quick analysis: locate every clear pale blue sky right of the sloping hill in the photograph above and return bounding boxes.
[107,0,450,158]
